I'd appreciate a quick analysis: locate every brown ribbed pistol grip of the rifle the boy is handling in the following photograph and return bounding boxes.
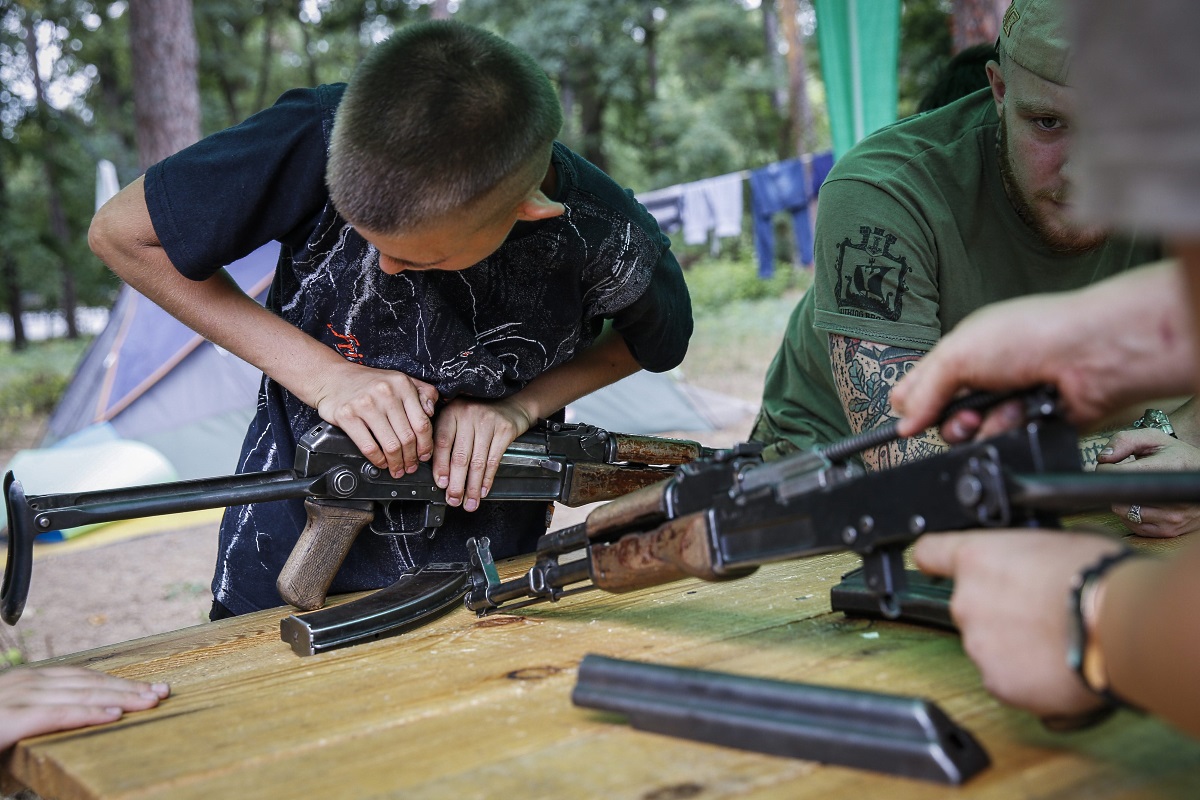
[275,498,374,610]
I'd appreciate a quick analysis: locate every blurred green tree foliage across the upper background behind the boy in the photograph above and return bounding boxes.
[0,0,952,331]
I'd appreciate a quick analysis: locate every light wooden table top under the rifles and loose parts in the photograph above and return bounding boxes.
[2,534,1200,800]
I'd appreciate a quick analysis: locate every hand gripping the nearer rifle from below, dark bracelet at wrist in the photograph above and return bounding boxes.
[913,530,1121,717]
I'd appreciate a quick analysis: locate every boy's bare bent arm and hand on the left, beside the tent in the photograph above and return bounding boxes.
[88,178,437,475]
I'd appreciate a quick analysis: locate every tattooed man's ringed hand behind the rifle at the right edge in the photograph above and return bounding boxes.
[1097,428,1200,539]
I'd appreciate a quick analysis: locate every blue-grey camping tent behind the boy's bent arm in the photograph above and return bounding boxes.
[42,242,278,479]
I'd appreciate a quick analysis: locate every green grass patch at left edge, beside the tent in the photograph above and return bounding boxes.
[0,338,90,447]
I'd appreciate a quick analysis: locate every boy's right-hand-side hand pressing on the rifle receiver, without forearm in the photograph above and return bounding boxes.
[433,397,533,511]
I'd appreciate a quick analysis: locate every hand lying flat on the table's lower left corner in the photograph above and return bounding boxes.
[0,667,170,751]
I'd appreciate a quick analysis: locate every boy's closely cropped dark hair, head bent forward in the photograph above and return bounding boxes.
[325,20,563,234]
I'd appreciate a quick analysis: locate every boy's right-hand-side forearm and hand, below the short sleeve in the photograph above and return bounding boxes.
[433,325,641,511]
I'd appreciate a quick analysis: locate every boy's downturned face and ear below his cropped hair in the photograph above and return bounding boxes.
[355,157,565,275]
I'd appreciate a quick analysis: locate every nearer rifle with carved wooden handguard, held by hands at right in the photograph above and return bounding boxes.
[466,391,1200,618]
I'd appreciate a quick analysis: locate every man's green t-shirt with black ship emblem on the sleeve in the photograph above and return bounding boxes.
[752,89,1159,458]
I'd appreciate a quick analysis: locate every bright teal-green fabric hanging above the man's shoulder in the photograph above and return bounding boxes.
[816,0,900,158]
